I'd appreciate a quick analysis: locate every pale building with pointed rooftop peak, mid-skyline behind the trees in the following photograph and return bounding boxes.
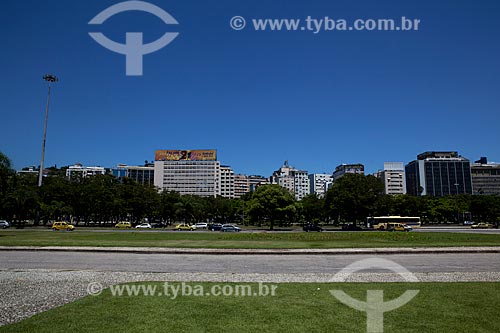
[271,161,310,200]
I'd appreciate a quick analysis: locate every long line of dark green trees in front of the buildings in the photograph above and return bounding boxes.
[0,152,500,229]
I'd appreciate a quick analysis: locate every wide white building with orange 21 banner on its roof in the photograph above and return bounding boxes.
[154,150,221,197]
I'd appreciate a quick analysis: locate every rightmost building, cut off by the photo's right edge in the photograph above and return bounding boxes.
[470,157,500,194]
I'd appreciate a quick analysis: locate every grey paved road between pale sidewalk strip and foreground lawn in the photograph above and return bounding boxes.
[0,251,500,274]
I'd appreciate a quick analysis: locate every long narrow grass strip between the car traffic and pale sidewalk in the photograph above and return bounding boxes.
[0,230,500,249]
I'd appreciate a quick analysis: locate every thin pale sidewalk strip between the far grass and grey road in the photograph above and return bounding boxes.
[0,246,500,255]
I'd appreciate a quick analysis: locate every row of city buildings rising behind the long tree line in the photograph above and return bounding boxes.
[15,149,500,200]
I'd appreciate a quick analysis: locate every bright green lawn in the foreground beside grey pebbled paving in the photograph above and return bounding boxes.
[0,282,500,333]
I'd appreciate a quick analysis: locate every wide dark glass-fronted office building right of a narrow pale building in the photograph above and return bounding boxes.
[405,151,472,197]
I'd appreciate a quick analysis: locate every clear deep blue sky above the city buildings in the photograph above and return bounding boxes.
[0,0,500,176]
